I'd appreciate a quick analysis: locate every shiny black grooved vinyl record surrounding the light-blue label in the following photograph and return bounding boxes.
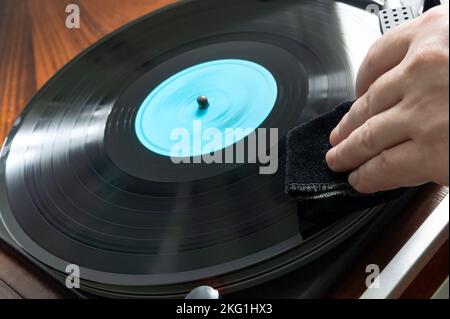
[0,0,380,297]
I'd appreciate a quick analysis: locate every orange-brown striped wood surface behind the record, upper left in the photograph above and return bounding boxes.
[0,0,175,141]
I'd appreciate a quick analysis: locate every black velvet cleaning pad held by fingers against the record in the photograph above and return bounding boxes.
[286,102,404,222]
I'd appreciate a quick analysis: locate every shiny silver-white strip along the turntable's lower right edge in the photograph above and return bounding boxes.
[360,195,449,299]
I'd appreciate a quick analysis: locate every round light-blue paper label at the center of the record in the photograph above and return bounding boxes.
[135,59,278,157]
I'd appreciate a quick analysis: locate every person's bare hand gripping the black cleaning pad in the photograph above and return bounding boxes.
[326,5,449,193]
